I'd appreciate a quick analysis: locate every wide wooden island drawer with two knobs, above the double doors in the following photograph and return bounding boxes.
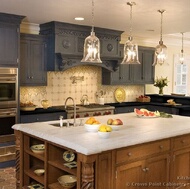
[116,139,170,164]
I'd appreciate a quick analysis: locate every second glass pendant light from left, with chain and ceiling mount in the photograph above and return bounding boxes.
[121,2,140,64]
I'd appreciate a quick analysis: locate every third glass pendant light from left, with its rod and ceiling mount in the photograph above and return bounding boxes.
[153,10,167,66]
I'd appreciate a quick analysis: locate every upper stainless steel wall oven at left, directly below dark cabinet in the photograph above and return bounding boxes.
[0,67,18,108]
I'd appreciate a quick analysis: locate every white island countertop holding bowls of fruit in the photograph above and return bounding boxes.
[13,113,190,155]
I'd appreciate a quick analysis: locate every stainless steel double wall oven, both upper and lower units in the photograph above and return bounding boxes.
[0,67,18,135]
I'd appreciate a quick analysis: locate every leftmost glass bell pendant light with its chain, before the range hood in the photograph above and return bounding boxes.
[81,0,102,63]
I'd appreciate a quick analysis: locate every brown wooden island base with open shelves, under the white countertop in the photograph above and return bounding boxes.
[15,130,190,189]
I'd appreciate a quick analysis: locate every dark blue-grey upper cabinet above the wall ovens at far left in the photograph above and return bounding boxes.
[0,13,24,67]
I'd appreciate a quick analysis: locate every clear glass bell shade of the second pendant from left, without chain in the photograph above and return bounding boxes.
[121,37,140,64]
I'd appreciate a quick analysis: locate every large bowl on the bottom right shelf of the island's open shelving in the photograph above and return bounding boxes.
[57,175,77,188]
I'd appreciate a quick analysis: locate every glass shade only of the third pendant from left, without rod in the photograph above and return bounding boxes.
[153,41,167,66]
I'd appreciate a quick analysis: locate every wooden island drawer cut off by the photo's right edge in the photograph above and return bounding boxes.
[173,135,190,150]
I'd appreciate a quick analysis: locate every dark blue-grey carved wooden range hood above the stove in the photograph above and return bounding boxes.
[40,21,123,71]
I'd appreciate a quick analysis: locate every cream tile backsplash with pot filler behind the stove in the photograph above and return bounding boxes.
[20,66,144,107]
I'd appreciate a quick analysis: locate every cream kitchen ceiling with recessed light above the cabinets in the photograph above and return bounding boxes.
[0,0,190,45]
